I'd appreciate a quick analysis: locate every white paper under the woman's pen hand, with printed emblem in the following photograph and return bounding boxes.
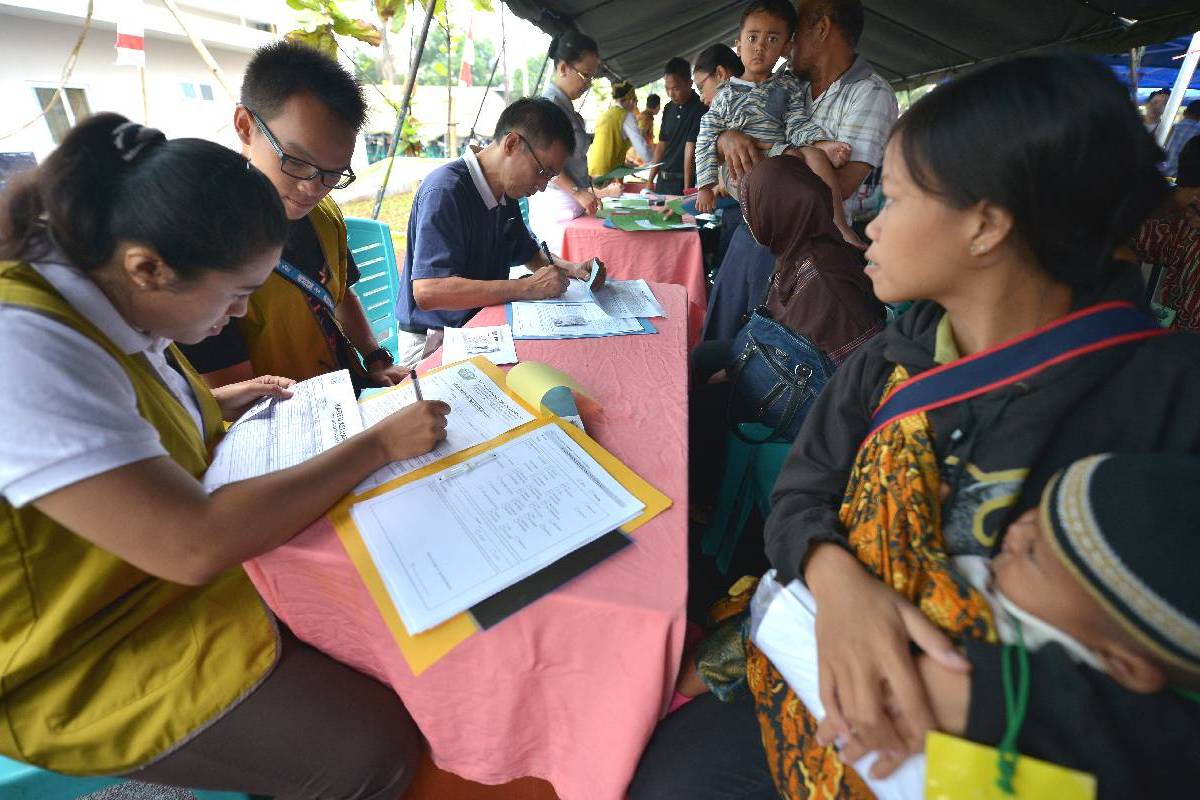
[354,363,534,494]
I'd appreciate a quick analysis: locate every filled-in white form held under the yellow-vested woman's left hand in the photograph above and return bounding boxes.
[204,369,362,492]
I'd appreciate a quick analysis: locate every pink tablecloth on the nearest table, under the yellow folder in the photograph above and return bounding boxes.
[246,284,688,800]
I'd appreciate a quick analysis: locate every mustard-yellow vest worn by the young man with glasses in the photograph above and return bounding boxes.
[236,197,349,380]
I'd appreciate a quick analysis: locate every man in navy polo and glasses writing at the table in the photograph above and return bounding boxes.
[396,97,604,366]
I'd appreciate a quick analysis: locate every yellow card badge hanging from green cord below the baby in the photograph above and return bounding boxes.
[925,732,1096,800]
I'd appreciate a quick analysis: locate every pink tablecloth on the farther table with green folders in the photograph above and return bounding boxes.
[562,216,708,349]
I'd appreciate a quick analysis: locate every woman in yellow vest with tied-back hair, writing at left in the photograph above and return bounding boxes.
[0,114,449,800]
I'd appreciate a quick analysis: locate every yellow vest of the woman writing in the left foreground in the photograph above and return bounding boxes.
[0,261,278,775]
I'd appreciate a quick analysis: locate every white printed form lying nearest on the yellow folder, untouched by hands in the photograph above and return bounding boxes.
[350,426,644,633]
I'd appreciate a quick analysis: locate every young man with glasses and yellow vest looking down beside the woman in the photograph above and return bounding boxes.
[175,42,407,389]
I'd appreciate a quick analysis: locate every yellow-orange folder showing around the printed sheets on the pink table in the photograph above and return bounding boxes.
[328,356,671,675]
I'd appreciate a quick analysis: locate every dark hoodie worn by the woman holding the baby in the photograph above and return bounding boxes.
[764,266,1200,798]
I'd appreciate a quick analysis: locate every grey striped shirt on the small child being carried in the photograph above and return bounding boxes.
[696,71,830,188]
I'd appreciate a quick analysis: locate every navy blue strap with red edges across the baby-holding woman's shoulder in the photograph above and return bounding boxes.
[868,302,1168,438]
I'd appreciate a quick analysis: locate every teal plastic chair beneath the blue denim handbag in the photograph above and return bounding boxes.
[701,422,792,575]
